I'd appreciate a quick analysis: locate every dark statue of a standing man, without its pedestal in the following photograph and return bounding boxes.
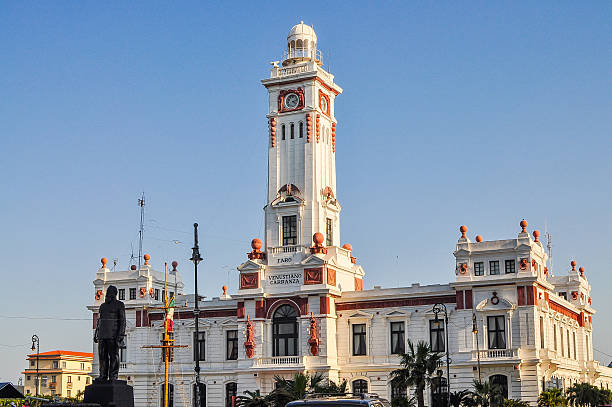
[94,285,125,381]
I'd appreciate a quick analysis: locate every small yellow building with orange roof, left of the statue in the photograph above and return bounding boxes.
[22,350,93,397]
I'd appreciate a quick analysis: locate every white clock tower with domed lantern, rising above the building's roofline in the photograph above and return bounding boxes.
[239,22,363,293]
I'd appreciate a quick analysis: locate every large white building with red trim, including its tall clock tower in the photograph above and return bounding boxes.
[89,23,612,406]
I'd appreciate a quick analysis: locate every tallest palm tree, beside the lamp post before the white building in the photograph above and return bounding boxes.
[391,340,442,407]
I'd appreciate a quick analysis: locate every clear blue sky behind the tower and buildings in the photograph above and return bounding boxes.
[0,1,612,382]
